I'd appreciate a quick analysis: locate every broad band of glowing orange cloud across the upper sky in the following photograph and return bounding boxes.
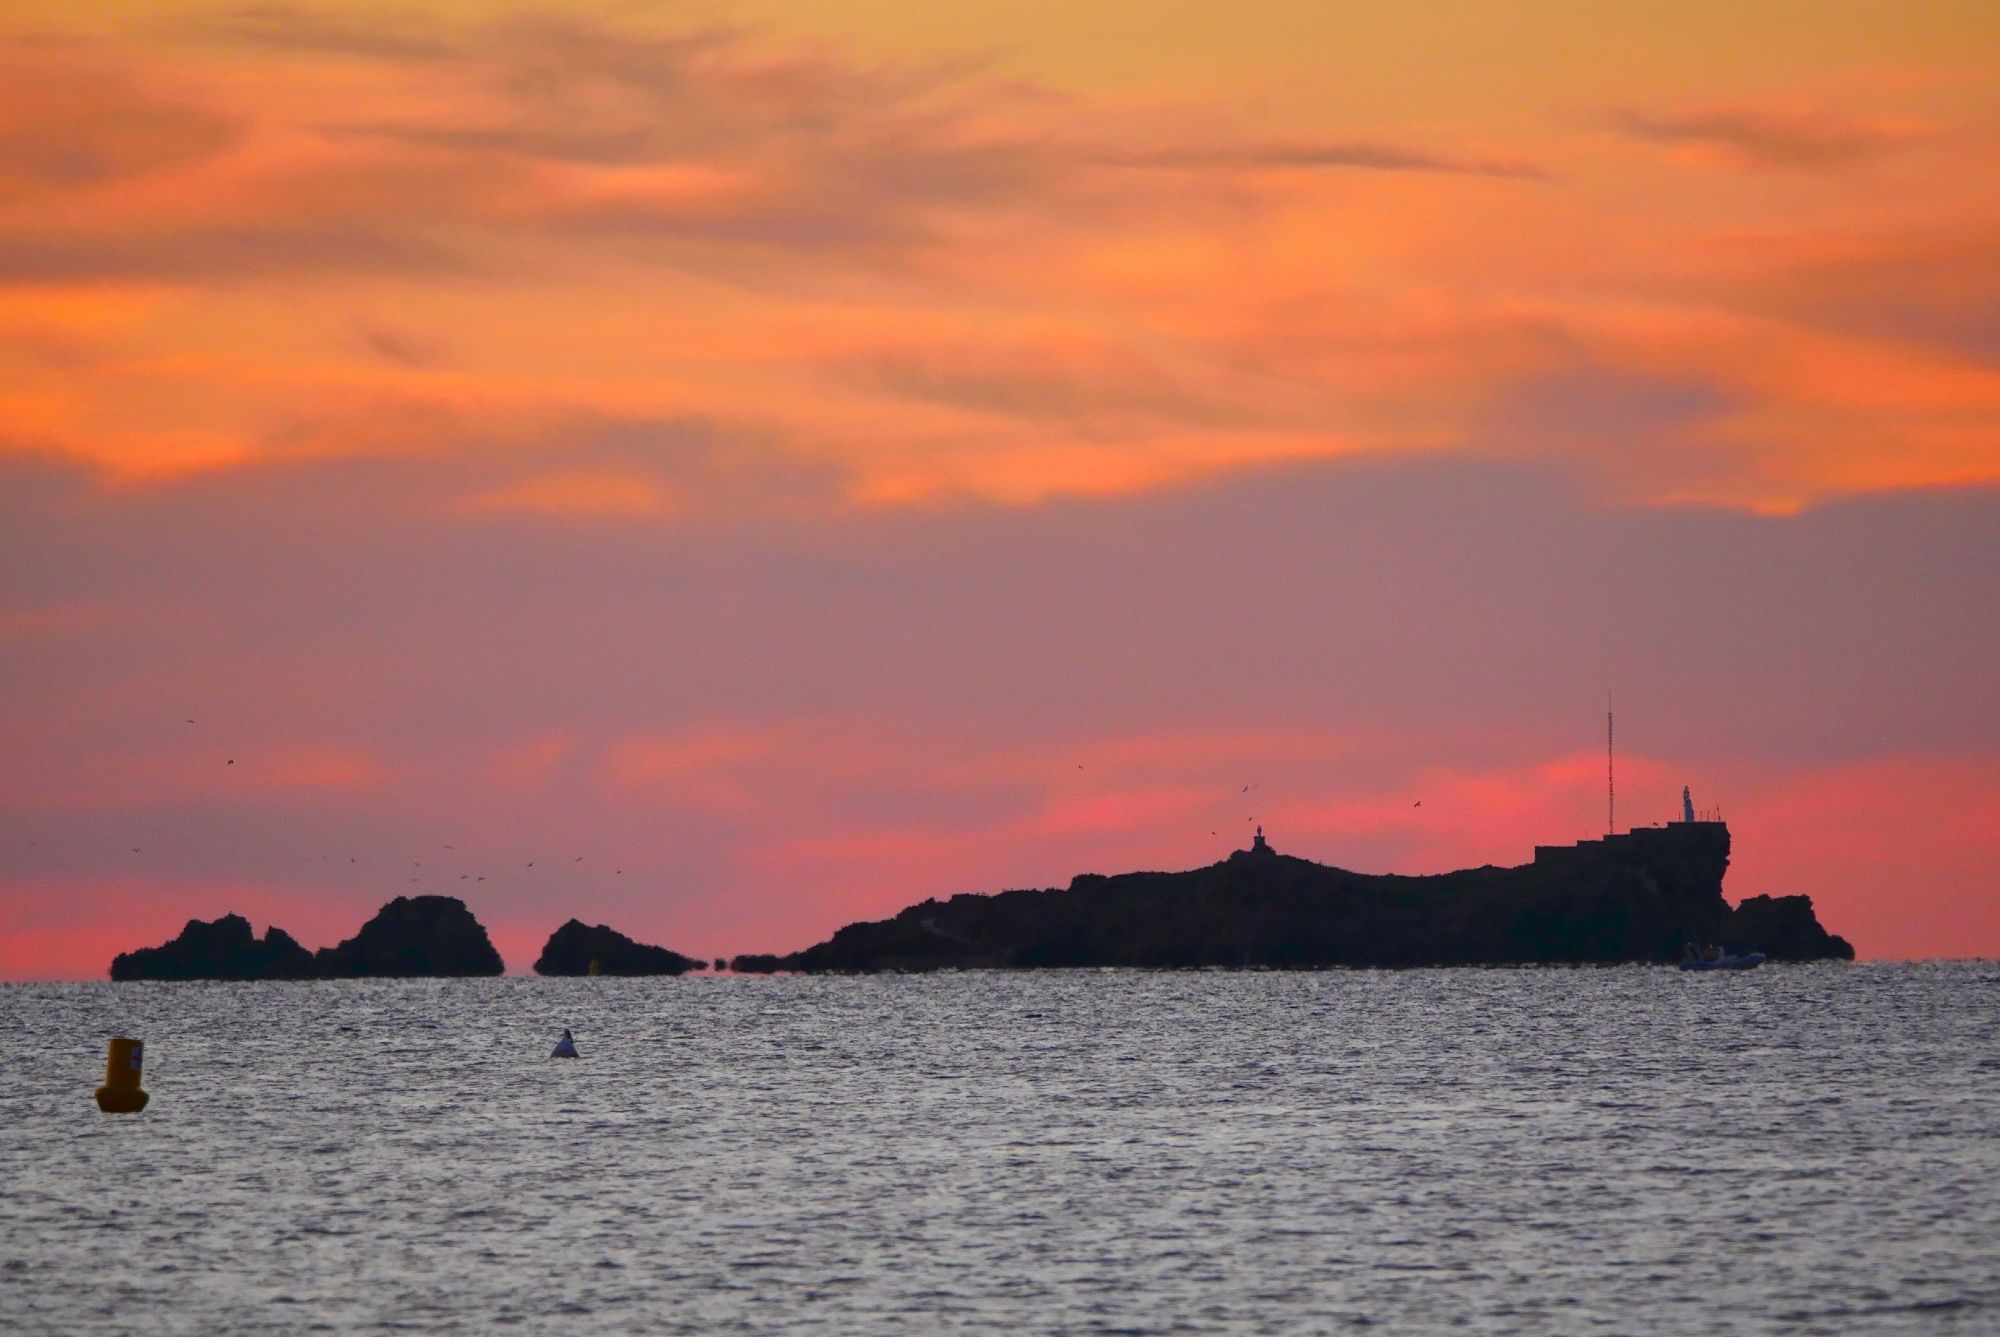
[0,6,1994,522]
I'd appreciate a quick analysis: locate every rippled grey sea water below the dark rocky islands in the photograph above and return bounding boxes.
[0,963,2000,1337]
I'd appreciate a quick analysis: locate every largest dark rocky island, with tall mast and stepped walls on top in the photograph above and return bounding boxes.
[732,823,1852,973]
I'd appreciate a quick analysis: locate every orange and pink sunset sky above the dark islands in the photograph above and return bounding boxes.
[0,0,2000,979]
